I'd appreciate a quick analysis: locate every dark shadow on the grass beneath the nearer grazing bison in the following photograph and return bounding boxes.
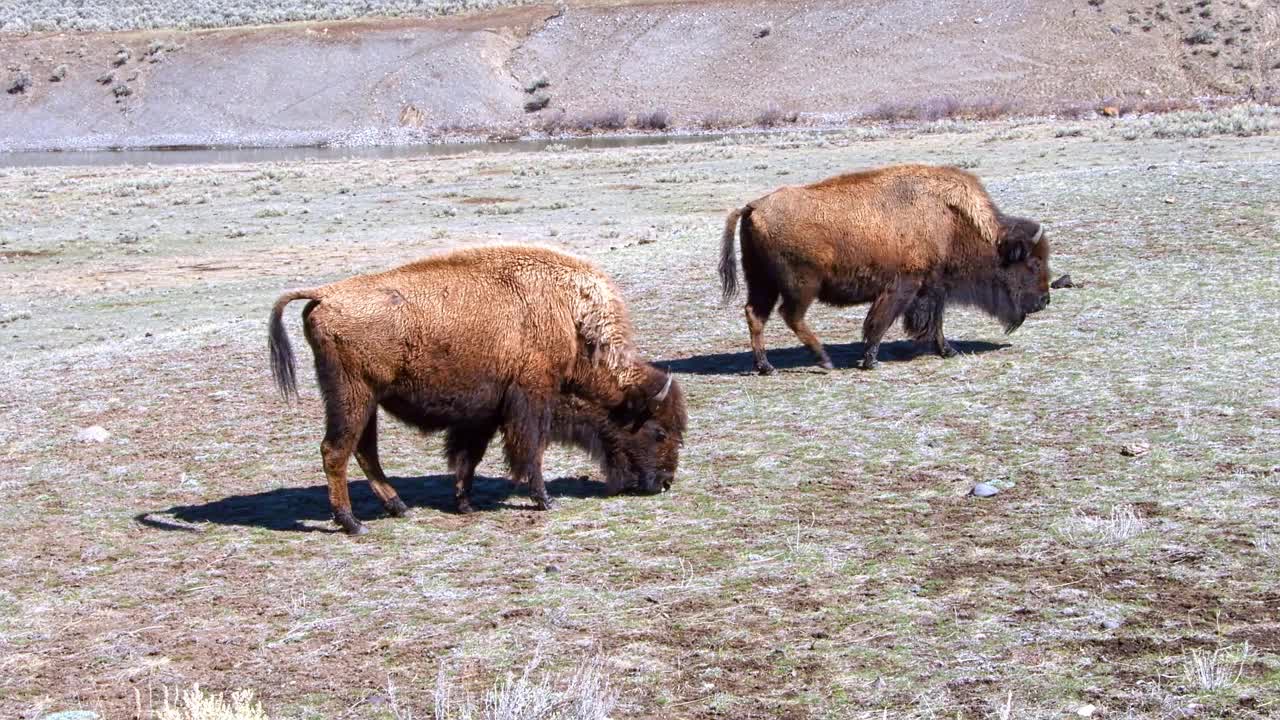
[134,475,604,533]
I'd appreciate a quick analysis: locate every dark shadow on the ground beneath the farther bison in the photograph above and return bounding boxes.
[654,340,1010,375]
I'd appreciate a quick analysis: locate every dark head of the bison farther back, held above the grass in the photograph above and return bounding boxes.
[996,218,1050,333]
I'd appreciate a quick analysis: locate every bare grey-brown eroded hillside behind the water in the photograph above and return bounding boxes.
[0,0,1280,150]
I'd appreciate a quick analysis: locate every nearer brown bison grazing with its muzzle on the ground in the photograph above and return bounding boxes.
[269,246,686,534]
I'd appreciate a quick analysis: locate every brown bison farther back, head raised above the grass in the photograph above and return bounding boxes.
[719,165,1050,374]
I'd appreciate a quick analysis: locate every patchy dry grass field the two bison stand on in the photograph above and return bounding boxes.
[0,110,1280,720]
